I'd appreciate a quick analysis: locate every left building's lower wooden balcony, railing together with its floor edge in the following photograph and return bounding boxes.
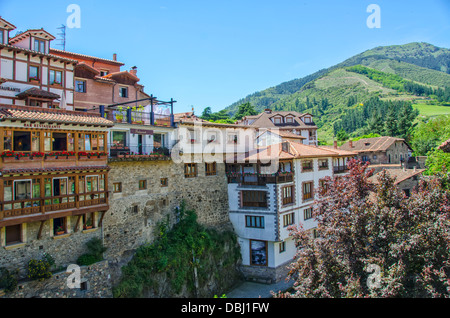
[0,191,109,227]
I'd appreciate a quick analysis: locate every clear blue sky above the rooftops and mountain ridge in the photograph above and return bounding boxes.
[0,0,450,114]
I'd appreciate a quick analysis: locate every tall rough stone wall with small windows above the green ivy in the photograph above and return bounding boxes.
[103,160,231,280]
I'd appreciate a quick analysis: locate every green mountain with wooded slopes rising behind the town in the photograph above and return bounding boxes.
[221,43,450,141]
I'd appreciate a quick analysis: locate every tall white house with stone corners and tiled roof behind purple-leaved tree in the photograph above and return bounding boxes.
[227,141,354,282]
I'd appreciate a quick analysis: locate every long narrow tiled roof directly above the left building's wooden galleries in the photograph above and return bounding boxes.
[0,106,114,126]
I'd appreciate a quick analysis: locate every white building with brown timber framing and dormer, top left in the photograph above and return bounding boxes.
[0,18,78,110]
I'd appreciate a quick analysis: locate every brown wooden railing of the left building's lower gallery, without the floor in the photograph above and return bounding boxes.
[0,191,108,220]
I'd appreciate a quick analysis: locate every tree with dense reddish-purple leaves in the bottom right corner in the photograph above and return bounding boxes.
[276,160,450,298]
